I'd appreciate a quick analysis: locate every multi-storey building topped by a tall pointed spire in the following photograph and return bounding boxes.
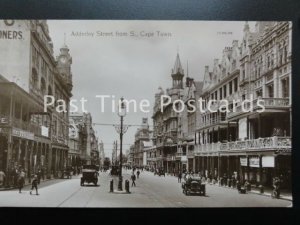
[149,54,184,172]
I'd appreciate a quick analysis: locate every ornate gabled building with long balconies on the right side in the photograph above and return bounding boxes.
[195,22,291,190]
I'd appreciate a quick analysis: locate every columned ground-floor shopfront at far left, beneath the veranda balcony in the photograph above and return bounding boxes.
[0,127,51,185]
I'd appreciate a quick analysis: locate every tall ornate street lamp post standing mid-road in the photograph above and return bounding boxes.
[115,97,128,191]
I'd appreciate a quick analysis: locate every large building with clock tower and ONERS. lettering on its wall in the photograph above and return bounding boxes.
[0,20,72,181]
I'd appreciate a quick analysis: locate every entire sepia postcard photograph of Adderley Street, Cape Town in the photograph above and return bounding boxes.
[0,19,293,208]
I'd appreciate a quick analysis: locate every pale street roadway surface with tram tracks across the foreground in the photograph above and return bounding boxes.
[0,170,292,208]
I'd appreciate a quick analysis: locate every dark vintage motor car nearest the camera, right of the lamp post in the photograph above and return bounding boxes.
[181,177,205,196]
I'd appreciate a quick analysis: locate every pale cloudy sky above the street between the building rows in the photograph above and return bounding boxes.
[48,20,255,157]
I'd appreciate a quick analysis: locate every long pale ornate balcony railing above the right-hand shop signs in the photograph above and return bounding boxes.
[220,136,291,151]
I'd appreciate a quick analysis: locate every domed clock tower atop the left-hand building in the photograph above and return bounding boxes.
[57,41,72,88]
